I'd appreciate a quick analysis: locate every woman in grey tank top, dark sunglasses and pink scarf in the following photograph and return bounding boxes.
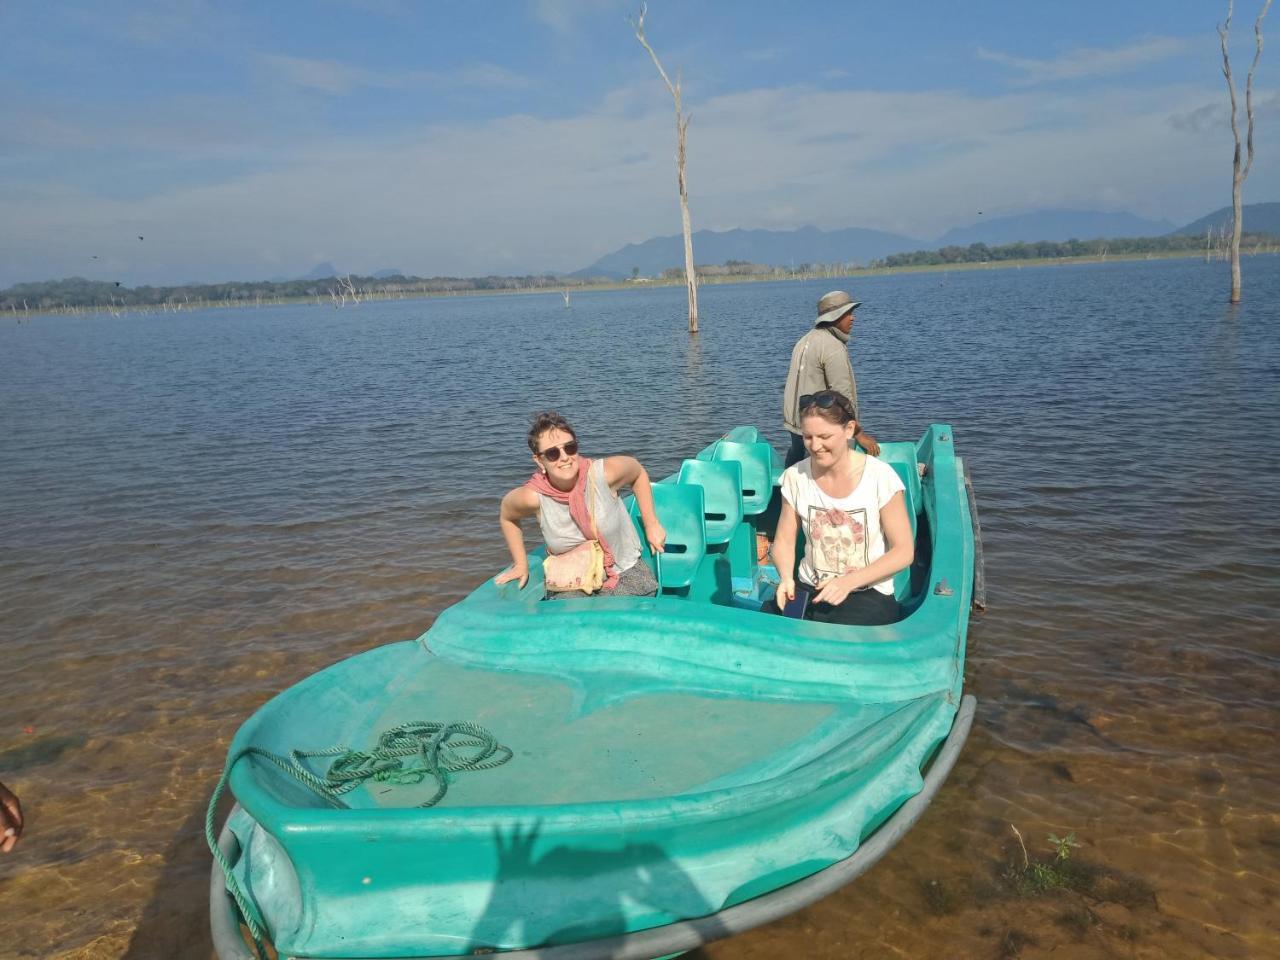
[494,411,667,596]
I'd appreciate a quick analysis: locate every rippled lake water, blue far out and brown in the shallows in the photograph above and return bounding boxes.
[0,256,1280,960]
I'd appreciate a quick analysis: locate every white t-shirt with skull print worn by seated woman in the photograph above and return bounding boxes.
[781,456,904,594]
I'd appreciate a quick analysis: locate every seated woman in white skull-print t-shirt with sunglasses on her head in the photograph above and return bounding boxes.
[773,390,915,626]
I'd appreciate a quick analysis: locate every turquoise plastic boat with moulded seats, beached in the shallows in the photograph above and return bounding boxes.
[210,424,982,960]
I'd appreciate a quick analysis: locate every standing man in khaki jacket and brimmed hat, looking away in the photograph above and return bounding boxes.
[782,291,879,467]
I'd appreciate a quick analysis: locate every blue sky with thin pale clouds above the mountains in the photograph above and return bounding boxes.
[0,0,1280,287]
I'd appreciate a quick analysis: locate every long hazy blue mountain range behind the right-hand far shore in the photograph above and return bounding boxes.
[568,204,1280,280]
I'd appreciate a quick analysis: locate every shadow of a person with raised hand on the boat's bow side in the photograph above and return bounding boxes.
[470,820,727,952]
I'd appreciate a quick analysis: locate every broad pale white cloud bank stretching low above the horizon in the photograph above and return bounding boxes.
[0,77,1280,285]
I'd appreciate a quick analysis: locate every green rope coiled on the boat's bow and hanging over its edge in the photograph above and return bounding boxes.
[205,721,512,960]
